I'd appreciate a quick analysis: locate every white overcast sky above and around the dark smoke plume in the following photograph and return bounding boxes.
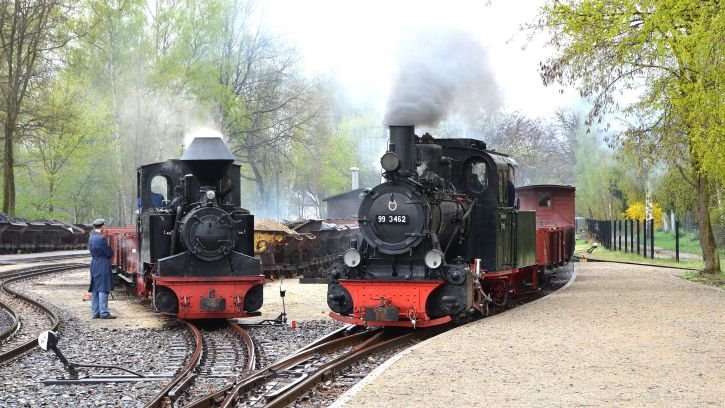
[257,0,576,117]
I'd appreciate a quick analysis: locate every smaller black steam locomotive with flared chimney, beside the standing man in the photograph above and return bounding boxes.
[108,138,264,319]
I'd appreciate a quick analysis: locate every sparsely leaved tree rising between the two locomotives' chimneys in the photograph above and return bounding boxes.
[214,1,324,215]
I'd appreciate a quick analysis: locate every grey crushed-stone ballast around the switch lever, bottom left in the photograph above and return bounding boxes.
[0,309,189,407]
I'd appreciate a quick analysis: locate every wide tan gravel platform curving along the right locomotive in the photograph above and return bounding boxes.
[335,263,725,407]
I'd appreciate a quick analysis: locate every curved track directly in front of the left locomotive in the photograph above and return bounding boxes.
[146,321,256,408]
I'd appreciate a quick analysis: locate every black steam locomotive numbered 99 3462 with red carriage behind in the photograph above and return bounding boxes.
[327,126,574,327]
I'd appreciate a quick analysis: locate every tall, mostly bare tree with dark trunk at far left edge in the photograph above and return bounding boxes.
[0,0,69,215]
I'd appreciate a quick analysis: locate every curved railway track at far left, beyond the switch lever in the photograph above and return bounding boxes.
[0,264,87,364]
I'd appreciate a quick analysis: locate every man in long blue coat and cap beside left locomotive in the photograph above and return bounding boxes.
[88,218,116,319]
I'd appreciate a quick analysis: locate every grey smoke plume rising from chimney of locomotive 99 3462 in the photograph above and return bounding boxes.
[384,27,501,126]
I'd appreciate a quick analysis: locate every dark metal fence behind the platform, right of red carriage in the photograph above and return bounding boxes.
[584,219,680,262]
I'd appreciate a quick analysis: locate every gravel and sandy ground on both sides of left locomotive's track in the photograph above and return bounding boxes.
[0,268,340,407]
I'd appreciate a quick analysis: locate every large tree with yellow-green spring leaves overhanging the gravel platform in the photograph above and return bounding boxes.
[531,0,725,273]
